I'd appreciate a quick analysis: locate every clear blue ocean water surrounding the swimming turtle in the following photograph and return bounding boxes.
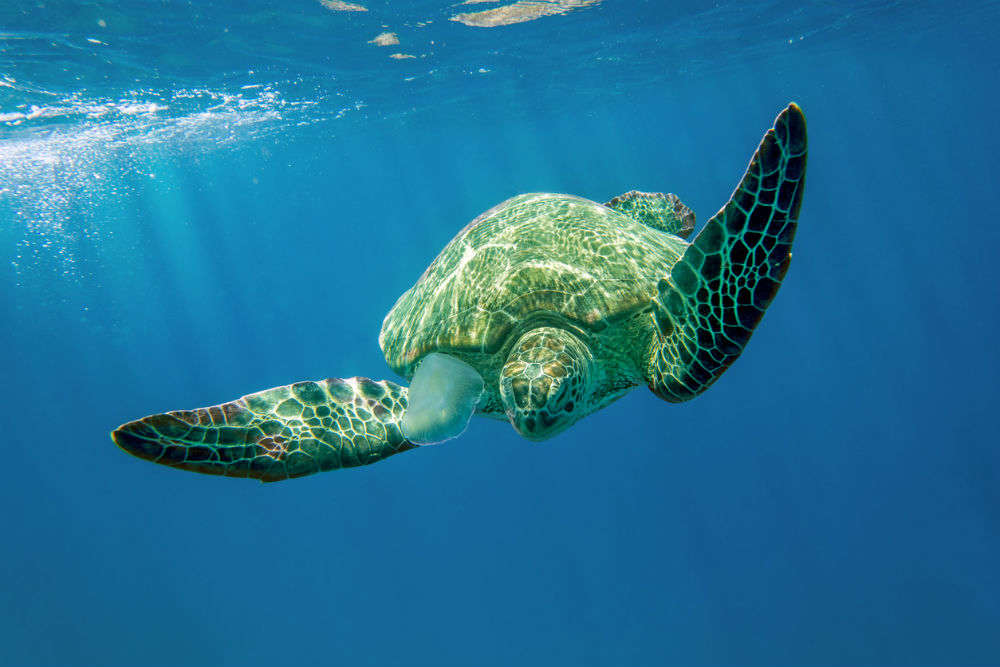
[0,0,1000,666]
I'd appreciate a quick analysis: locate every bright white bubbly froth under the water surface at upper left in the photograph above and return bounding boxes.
[0,77,364,280]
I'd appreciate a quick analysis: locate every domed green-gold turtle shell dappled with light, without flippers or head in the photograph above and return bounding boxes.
[379,194,687,378]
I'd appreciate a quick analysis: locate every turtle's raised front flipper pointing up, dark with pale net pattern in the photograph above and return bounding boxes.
[647,104,806,402]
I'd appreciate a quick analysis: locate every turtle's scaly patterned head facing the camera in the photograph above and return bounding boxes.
[500,327,593,440]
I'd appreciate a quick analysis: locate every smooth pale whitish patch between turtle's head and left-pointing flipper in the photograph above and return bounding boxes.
[400,352,483,445]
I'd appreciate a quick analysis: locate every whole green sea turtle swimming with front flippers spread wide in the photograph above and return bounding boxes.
[111,104,806,481]
